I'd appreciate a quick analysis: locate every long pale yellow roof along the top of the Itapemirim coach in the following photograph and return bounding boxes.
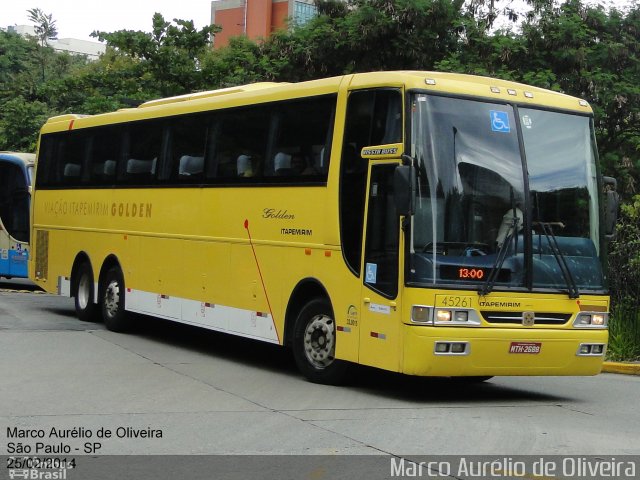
[37,71,592,133]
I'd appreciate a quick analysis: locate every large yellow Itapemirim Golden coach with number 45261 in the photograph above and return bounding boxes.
[29,72,613,383]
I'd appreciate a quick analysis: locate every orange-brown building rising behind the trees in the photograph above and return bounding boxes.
[211,0,317,48]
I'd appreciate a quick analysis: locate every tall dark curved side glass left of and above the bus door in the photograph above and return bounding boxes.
[340,89,402,276]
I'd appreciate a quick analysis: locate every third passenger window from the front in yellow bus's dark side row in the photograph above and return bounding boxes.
[167,115,210,183]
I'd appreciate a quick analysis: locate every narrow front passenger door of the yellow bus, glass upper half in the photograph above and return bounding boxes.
[359,162,402,371]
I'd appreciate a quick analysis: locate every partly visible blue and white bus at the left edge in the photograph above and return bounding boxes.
[0,152,36,278]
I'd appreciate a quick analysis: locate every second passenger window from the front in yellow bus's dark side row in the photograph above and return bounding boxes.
[213,106,271,182]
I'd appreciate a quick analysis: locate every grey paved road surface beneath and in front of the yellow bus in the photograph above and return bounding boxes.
[0,281,640,478]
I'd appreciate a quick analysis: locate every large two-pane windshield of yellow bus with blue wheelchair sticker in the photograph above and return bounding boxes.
[408,94,604,297]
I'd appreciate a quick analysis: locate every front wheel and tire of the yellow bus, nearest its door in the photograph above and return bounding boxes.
[292,298,349,385]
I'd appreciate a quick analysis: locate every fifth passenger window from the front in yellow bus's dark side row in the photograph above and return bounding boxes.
[89,127,122,185]
